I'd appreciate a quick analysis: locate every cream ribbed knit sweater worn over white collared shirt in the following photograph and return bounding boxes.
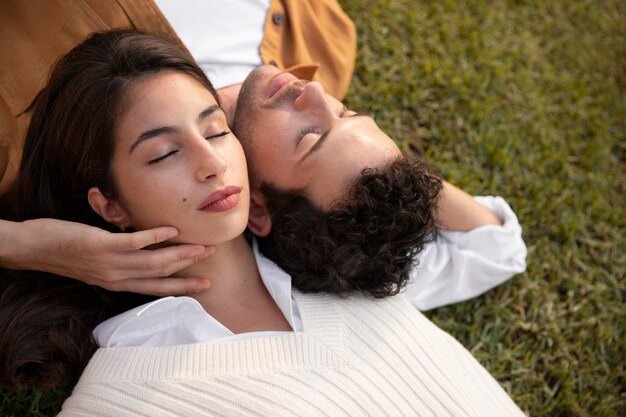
[60,293,524,417]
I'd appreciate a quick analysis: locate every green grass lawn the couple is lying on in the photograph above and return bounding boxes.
[0,0,626,417]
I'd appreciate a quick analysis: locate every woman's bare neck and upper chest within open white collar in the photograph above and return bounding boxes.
[169,235,291,333]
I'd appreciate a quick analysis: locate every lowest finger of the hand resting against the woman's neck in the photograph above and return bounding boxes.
[109,278,211,297]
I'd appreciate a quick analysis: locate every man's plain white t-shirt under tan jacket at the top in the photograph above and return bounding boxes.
[155,0,270,88]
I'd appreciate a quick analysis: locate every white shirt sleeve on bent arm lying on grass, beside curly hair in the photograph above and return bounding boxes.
[404,197,527,310]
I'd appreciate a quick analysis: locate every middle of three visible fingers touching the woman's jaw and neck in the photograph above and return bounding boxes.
[118,245,215,279]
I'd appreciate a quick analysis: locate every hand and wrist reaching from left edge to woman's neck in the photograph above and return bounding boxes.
[0,219,215,295]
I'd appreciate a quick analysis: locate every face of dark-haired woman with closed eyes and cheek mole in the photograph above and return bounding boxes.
[111,72,250,245]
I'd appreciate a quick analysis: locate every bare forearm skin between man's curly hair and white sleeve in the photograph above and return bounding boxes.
[435,181,502,231]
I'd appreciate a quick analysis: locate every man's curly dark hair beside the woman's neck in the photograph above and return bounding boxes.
[259,158,442,298]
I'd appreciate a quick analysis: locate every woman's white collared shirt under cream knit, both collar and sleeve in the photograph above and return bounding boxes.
[94,197,527,347]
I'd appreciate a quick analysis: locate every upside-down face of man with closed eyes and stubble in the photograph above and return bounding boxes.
[234,65,401,209]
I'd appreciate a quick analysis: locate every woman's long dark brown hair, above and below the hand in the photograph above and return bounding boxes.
[0,30,218,386]
